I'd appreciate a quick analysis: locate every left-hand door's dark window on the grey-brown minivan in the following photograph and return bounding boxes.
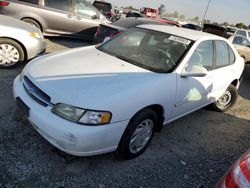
[44,0,72,12]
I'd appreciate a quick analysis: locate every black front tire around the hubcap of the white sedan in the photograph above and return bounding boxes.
[115,109,158,160]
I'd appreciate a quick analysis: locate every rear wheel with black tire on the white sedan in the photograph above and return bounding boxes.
[212,84,238,112]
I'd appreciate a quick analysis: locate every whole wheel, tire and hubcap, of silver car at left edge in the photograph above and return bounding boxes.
[0,39,24,68]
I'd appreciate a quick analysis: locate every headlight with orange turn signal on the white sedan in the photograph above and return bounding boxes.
[52,103,111,125]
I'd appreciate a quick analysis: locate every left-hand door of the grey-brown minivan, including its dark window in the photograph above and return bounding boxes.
[40,0,74,35]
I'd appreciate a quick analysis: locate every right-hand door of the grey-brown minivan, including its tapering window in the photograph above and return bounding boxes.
[74,0,105,40]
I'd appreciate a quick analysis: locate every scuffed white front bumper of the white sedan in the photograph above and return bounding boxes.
[13,76,128,156]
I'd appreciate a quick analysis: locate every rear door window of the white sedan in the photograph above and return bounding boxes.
[215,40,229,68]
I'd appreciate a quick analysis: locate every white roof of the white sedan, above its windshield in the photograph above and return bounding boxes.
[137,24,223,41]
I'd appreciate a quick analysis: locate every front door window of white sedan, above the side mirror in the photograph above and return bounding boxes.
[188,41,214,70]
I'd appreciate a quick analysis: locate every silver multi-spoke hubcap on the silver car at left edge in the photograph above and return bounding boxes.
[0,44,19,66]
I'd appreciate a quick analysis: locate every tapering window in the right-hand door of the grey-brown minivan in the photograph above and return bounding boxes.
[76,0,97,18]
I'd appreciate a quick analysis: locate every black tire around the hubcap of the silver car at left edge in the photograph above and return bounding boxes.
[0,38,25,68]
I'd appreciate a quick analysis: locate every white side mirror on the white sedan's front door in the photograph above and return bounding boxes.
[181,65,207,78]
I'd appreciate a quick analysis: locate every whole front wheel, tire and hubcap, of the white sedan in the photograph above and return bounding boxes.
[116,109,158,159]
